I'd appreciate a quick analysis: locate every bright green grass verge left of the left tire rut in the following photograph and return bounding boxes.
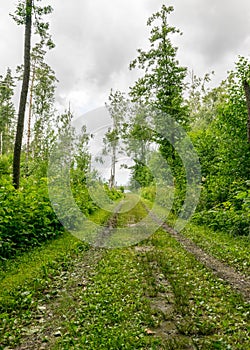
[0,205,116,349]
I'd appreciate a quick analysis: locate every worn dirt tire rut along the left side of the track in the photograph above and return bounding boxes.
[11,201,123,350]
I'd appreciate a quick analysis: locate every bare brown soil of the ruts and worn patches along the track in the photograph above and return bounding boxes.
[10,198,250,350]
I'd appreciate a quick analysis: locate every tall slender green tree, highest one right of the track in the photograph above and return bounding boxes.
[130,5,187,178]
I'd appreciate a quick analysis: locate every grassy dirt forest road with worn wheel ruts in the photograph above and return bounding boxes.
[0,194,249,350]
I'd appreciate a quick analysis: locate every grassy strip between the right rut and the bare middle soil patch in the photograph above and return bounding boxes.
[147,230,250,350]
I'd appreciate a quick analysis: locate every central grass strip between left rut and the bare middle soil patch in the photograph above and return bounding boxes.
[53,249,161,349]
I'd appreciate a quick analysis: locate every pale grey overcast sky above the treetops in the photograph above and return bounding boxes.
[0,0,250,115]
